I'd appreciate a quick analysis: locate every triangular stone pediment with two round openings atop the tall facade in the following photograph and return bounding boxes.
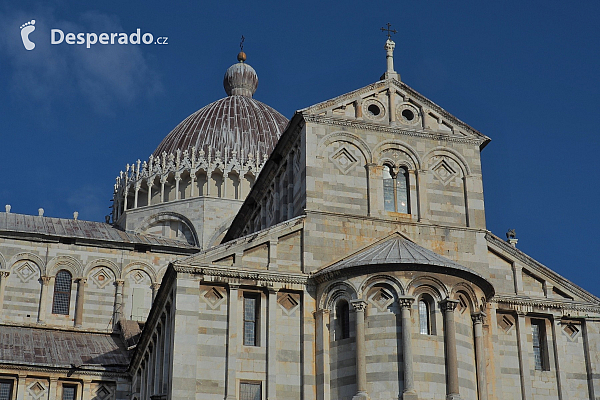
[300,79,490,148]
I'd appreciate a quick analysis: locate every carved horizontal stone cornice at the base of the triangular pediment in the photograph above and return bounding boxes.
[304,115,486,146]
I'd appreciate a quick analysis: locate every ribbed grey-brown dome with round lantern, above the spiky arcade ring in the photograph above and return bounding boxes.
[153,55,288,157]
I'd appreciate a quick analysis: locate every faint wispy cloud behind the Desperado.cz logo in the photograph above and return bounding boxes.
[0,9,162,114]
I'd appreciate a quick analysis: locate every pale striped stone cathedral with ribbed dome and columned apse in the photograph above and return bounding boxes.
[0,35,600,400]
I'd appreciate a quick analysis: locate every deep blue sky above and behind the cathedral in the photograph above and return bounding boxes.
[0,0,600,295]
